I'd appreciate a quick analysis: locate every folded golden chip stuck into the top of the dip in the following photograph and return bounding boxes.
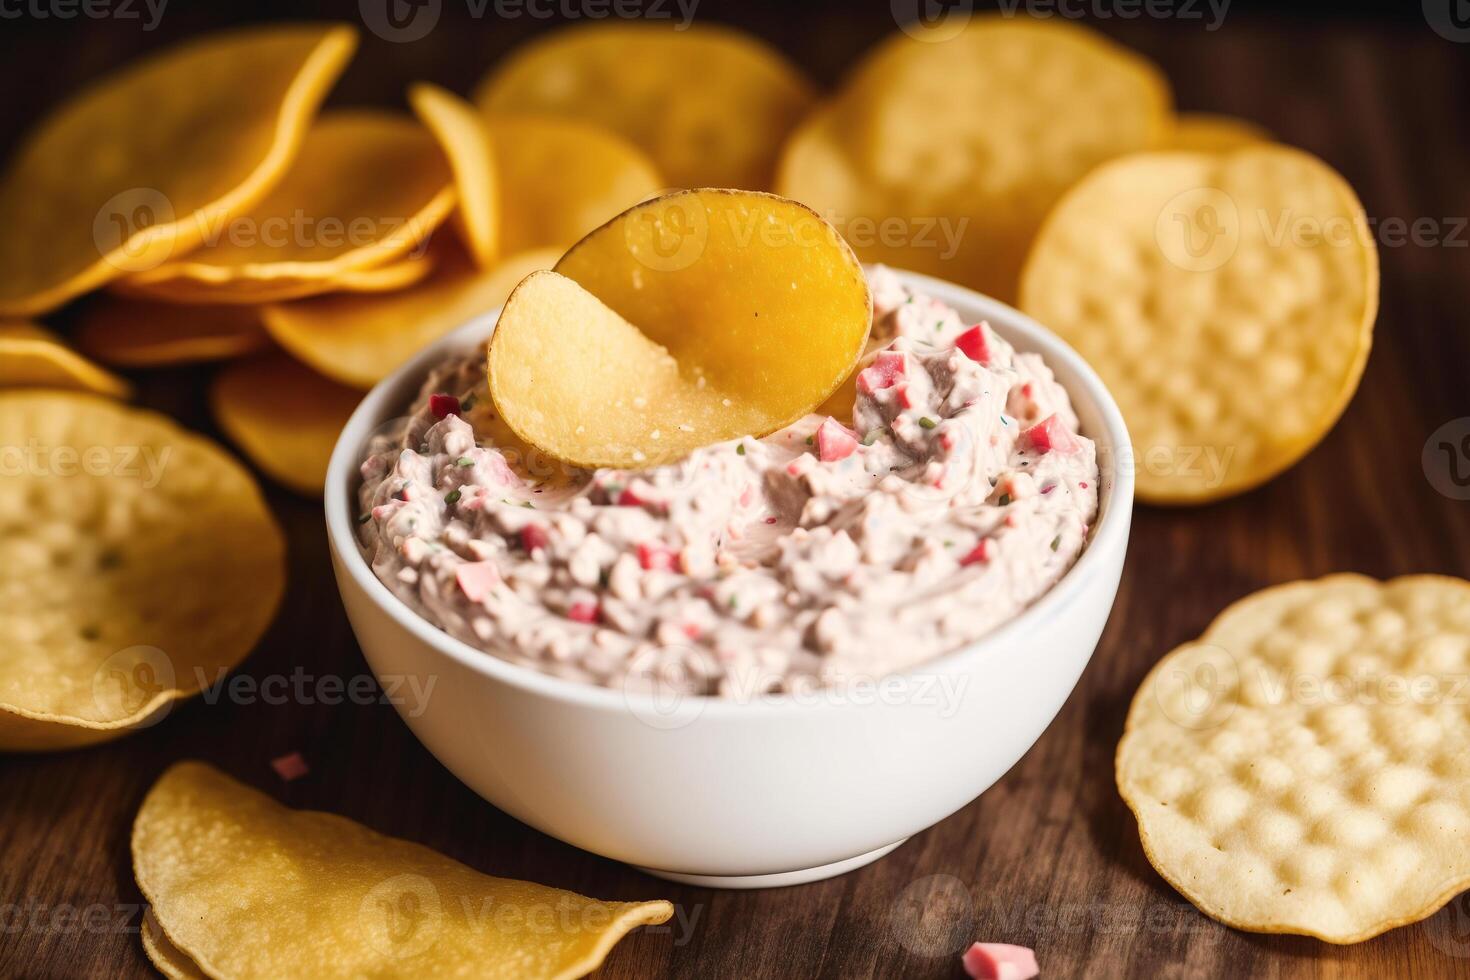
[490,191,872,467]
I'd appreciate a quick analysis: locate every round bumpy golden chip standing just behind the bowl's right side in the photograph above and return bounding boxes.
[1022,145,1379,504]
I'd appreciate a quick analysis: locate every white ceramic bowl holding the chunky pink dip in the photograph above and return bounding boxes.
[326,265,1133,887]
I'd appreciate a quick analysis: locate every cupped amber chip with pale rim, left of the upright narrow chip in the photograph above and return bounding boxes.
[118,109,457,290]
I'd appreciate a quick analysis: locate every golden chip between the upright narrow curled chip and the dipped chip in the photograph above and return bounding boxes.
[490,116,663,254]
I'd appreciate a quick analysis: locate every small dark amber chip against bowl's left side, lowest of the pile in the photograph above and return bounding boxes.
[209,354,362,497]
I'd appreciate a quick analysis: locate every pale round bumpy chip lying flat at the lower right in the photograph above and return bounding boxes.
[1117,574,1470,943]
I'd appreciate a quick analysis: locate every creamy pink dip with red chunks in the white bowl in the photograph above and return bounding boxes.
[360,269,1098,698]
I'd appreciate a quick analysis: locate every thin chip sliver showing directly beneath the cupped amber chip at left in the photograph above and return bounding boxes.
[109,244,434,306]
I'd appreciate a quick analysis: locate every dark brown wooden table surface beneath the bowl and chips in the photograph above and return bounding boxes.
[0,0,1470,977]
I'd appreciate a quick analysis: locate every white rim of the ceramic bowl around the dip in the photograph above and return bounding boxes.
[323,266,1135,716]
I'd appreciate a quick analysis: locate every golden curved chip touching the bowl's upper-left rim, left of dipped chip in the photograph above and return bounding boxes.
[262,248,562,388]
